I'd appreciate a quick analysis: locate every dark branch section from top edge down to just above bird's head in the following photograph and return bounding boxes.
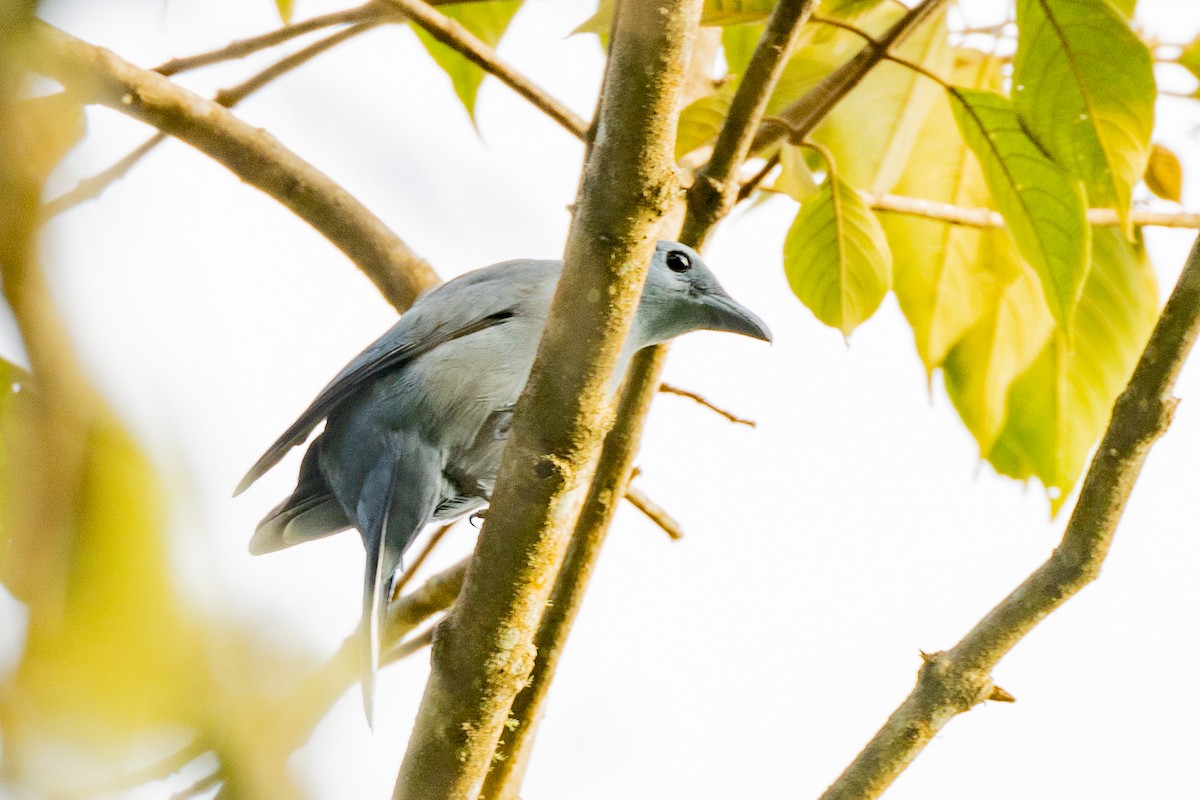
[682,0,812,248]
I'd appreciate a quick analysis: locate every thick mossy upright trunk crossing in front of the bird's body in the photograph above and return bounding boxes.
[395,0,701,800]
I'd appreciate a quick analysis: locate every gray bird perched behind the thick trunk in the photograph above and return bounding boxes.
[234,241,770,720]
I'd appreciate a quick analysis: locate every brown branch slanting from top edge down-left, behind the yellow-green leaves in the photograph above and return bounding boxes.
[750,0,947,154]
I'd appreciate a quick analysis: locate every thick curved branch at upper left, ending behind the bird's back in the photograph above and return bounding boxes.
[35,24,438,309]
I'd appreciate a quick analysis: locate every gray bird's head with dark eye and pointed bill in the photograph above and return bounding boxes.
[635,241,772,347]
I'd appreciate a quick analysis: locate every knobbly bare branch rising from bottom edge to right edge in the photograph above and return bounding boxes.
[822,230,1200,800]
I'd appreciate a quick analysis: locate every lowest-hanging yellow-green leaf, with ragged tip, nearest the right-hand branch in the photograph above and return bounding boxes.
[988,228,1158,513]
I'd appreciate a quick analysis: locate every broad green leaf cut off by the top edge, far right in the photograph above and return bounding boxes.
[1013,0,1157,236]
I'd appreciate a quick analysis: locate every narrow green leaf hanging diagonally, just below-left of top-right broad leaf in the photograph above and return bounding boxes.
[950,89,1091,331]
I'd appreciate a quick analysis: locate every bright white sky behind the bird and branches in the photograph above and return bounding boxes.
[9,0,1200,800]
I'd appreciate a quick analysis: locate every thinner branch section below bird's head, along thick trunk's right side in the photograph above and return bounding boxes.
[480,348,667,800]
